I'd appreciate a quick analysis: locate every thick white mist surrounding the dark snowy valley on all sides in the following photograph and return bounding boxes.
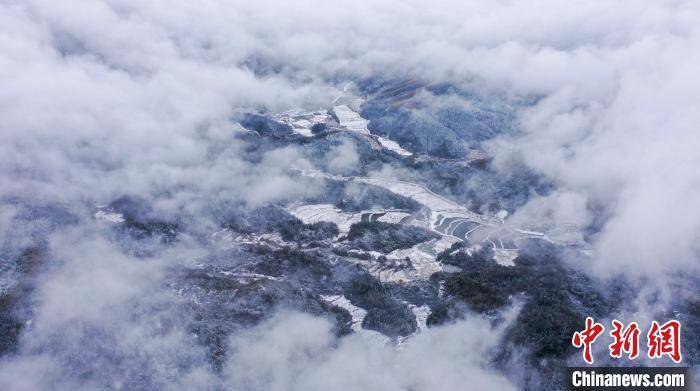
[0,0,700,390]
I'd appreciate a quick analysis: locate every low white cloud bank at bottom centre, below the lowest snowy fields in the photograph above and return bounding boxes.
[226,313,515,390]
